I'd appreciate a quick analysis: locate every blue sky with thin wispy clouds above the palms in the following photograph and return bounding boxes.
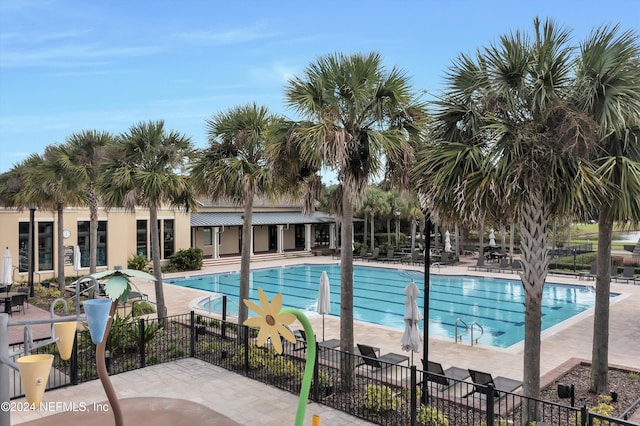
[0,0,640,173]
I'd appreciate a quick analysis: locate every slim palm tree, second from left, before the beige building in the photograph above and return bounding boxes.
[62,130,114,274]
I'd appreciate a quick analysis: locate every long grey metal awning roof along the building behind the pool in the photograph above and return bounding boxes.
[191,212,335,226]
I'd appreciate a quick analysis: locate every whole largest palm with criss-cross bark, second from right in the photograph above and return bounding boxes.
[415,19,600,421]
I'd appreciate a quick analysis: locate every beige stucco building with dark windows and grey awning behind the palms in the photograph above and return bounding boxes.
[0,200,336,282]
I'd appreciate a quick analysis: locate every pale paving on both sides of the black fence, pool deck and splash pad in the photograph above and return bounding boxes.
[12,256,640,426]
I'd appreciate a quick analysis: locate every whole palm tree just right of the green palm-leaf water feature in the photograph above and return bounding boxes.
[100,120,195,320]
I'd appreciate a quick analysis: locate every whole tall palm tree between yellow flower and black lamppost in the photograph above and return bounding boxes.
[274,53,424,387]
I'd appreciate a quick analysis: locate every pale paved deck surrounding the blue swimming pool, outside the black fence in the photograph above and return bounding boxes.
[155,256,640,378]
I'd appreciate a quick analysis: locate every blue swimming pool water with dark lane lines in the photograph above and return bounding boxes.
[164,264,613,348]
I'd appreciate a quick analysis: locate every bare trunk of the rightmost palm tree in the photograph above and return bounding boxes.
[589,212,613,394]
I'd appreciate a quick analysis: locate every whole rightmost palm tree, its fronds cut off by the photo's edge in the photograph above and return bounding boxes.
[575,26,640,394]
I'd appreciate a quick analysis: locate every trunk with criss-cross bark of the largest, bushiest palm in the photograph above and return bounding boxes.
[520,191,549,424]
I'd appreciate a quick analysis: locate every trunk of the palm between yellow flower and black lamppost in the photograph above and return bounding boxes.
[340,191,355,390]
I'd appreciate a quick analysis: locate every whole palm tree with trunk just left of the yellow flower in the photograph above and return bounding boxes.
[191,104,276,324]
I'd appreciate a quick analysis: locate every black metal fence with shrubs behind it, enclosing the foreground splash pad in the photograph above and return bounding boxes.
[11,312,633,426]
